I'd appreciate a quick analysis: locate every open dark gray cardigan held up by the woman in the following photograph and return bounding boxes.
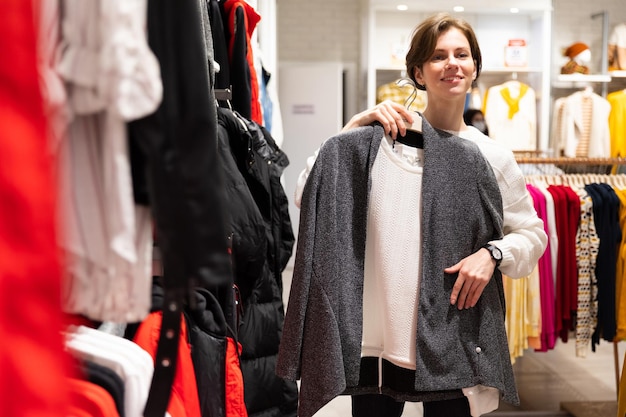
[276,120,519,417]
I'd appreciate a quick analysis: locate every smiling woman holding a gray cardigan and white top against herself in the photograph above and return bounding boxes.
[277,14,547,417]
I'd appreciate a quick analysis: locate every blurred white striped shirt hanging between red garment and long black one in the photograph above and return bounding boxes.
[49,0,162,322]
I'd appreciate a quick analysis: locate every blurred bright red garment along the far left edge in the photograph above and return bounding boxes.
[0,0,70,417]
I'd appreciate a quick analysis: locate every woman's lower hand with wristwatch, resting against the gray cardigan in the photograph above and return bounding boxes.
[444,248,496,310]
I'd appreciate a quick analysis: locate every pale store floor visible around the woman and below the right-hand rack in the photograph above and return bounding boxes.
[283,268,626,417]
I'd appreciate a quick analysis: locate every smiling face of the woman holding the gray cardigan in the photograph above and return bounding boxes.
[415,27,476,101]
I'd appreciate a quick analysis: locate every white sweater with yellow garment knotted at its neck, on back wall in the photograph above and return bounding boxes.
[482,81,537,151]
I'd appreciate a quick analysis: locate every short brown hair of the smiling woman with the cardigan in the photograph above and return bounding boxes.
[406,13,482,90]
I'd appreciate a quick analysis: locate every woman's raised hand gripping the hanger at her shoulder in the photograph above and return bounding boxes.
[341,100,413,139]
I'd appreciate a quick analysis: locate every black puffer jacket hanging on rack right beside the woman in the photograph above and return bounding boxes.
[218,109,298,417]
